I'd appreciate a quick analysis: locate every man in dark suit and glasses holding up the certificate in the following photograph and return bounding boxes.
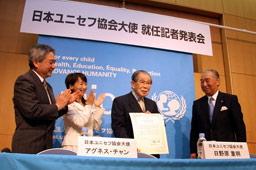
[111,70,159,157]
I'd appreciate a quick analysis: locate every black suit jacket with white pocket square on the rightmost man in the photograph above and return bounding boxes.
[190,92,246,153]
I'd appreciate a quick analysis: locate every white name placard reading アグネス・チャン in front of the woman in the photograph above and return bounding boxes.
[77,136,137,158]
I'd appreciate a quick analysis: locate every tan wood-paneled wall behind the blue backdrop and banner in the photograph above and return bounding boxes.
[0,0,256,153]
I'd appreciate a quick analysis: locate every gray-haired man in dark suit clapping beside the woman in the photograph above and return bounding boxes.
[12,44,78,154]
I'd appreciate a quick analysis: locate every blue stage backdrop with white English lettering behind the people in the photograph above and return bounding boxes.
[38,36,195,158]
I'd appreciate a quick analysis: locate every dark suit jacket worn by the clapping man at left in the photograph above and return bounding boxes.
[12,70,67,154]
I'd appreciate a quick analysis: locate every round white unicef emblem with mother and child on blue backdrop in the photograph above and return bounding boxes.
[152,91,187,123]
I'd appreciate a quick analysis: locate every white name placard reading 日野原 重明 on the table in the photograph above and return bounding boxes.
[203,141,250,159]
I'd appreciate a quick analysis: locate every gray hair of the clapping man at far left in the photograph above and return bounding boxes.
[28,44,55,68]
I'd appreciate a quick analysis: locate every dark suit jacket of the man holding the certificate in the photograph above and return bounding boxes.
[111,92,159,138]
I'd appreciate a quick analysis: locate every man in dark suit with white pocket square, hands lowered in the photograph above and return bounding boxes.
[190,69,246,159]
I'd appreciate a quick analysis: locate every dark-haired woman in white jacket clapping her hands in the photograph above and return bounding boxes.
[62,73,105,152]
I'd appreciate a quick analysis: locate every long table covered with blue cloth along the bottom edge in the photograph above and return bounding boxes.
[0,153,256,170]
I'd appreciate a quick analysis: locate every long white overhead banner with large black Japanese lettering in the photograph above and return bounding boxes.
[21,0,212,56]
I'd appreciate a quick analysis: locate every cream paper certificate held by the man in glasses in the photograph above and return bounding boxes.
[130,113,169,154]
